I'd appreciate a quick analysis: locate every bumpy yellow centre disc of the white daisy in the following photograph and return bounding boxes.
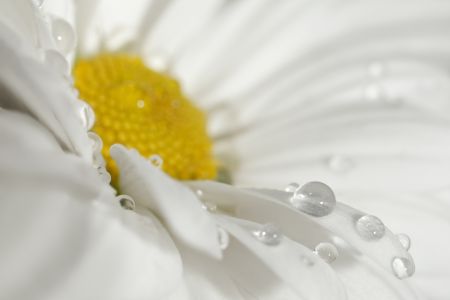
[74,54,217,182]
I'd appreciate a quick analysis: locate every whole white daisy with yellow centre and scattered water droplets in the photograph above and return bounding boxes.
[1,0,450,299]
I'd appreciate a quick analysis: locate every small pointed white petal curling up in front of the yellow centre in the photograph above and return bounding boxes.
[111,145,222,258]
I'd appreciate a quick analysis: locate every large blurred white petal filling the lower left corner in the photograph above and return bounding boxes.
[0,110,182,300]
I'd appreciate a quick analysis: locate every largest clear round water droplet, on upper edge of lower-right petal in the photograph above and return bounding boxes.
[289,181,336,217]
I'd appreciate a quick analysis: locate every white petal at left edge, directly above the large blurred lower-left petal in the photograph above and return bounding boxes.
[0,24,92,161]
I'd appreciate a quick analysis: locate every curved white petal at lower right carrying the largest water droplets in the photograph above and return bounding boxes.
[189,182,415,299]
